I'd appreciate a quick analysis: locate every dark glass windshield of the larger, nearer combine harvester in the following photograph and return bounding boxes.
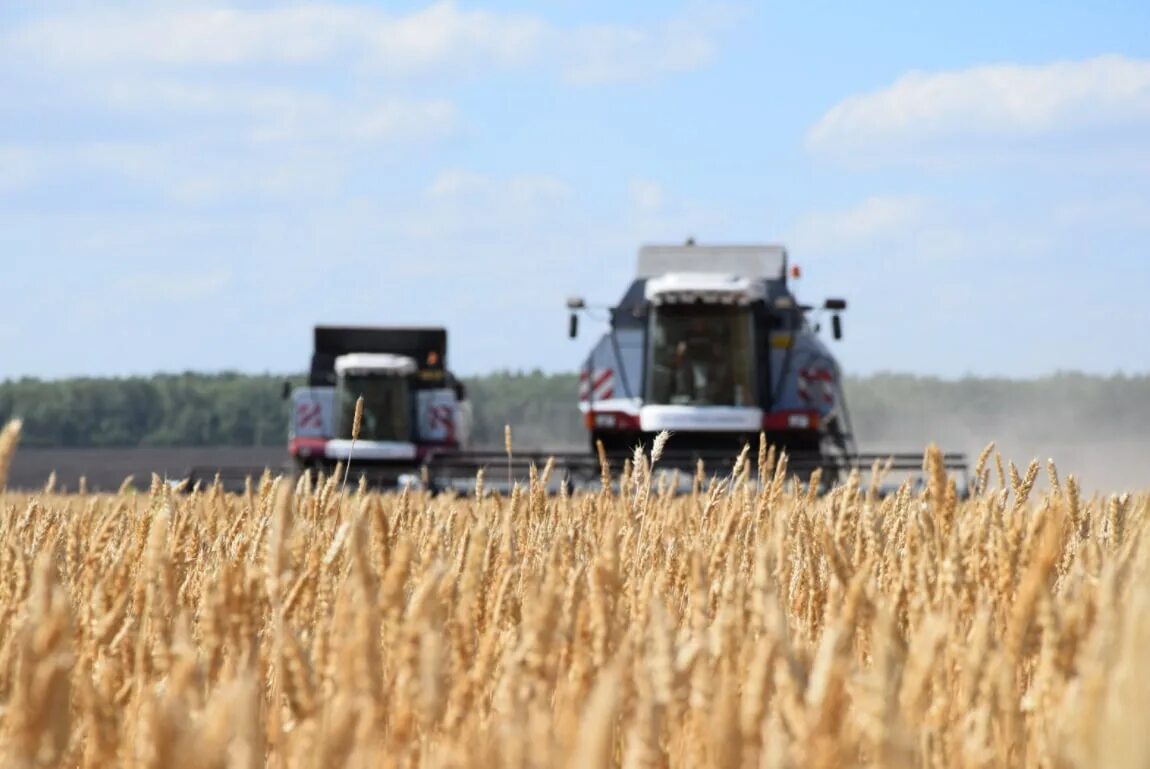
[647,305,756,406]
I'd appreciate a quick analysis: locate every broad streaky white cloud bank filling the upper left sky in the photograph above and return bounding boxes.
[0,0,721,197]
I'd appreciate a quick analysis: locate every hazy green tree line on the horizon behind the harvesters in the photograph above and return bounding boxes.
[0,371,1150,451]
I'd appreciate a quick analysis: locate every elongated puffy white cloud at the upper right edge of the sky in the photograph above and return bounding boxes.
[806,55,1150,164]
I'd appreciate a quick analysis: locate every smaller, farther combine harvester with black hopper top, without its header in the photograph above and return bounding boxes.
[289,326,472,480]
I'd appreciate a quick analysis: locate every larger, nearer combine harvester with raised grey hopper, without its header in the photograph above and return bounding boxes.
[568,241,966,482]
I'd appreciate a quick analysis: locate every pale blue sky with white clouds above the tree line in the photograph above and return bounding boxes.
[0,0,1150,377]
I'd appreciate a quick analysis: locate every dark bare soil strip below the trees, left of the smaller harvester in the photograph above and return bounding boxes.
[8,446,288,491]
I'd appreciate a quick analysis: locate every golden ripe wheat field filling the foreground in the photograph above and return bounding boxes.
[0,423,1150,769]
